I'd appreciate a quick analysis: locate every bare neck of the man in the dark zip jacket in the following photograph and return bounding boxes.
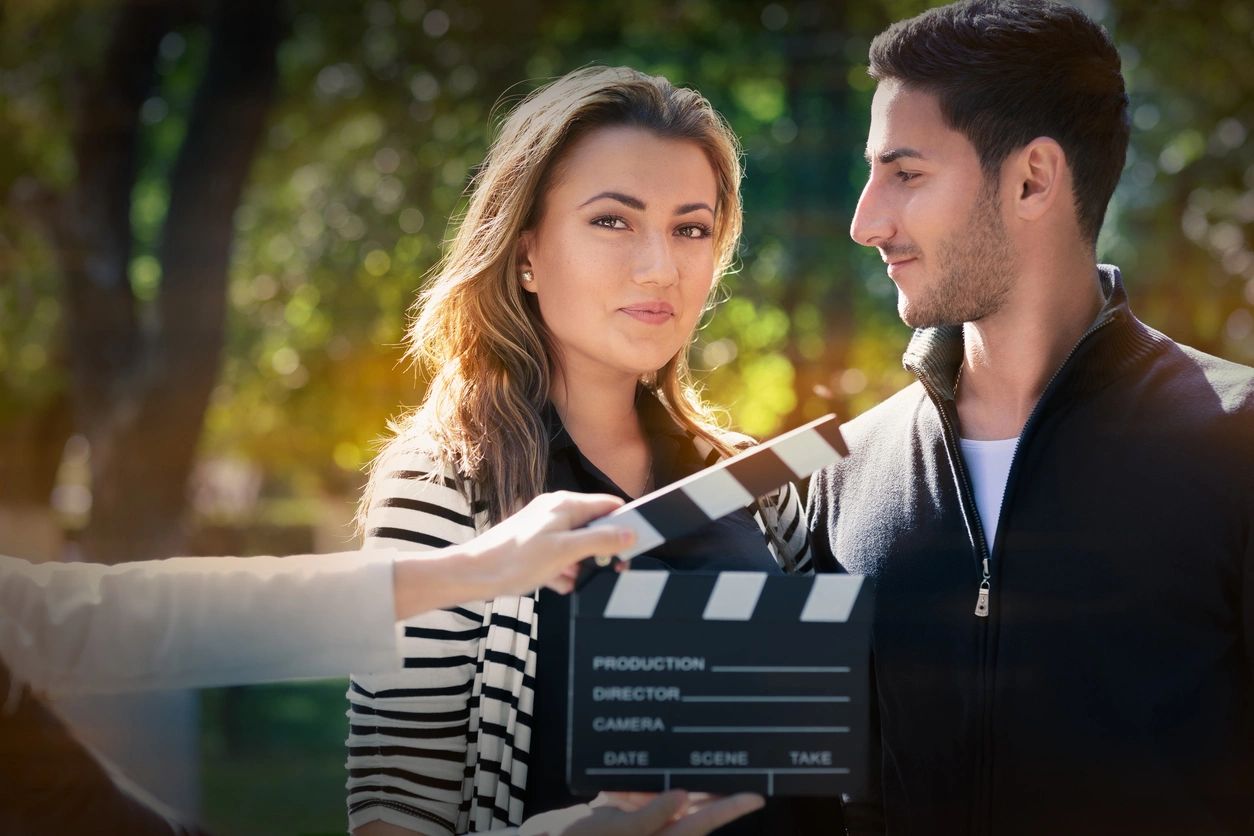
[957,259,1105,440]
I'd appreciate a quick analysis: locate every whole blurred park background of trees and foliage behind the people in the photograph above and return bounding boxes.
[0,0,1254,833]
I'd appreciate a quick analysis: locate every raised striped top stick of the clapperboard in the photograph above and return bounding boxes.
[581,415,849,583]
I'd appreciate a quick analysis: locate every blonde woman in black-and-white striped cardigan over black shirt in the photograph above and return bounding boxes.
[349,68,809,835]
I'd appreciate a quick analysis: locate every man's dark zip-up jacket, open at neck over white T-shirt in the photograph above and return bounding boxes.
[810,266,1254,836]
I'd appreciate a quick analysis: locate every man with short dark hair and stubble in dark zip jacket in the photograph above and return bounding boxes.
[810,0,1254,833]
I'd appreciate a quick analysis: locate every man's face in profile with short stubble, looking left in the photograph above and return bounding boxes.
[849,80,1014,328]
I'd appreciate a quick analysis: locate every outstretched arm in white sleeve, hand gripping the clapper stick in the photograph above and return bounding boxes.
[0,494,630,699]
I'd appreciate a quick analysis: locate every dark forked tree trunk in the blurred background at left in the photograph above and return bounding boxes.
[58,0,283,563]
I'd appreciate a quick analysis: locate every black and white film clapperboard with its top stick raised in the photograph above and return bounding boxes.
[567,415,872,796]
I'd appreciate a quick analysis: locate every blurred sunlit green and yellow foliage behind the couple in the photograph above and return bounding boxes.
[0,0,1254,496]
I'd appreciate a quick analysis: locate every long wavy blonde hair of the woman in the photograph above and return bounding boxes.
[362,66,741,523]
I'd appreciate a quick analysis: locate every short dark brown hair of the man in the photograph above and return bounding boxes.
[869,0,1129,243]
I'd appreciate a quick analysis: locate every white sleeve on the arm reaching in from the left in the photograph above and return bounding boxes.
[0,553,400,692]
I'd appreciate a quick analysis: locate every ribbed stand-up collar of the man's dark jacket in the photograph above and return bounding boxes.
[902,264,1170,401]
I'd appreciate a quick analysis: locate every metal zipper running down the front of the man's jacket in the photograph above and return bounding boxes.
[912,310,1115,832]
